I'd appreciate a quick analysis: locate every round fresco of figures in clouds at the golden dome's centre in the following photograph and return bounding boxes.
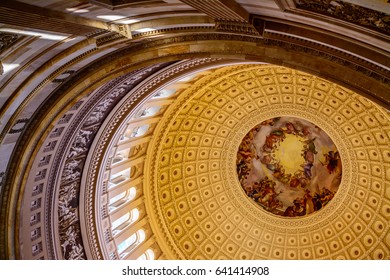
[236,116,342,217]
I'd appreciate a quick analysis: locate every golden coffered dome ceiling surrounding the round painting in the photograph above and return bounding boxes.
[144,65,390,259]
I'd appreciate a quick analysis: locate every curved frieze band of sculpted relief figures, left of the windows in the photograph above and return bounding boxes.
[52,64,170,259]
